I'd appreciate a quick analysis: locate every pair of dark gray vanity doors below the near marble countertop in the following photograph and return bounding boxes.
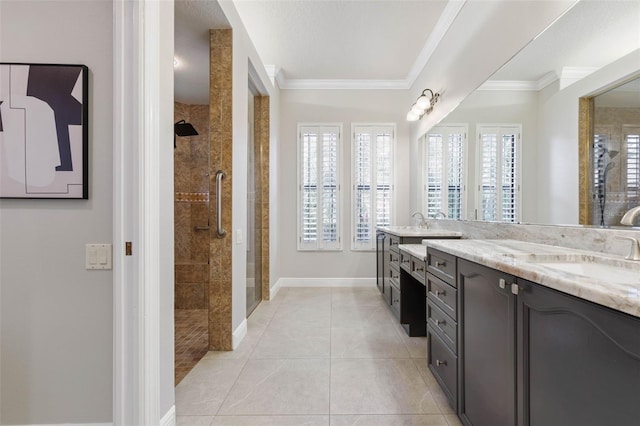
[452,259,640,426]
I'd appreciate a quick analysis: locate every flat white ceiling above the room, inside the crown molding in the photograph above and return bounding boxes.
[234,0,448,80]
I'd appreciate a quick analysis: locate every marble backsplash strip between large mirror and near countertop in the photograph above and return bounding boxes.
[429,219,640,256]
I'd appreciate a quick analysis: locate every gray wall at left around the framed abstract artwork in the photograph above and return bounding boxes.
[0,0,113,424]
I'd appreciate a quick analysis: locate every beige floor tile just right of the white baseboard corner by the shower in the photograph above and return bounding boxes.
[251,327,331,359]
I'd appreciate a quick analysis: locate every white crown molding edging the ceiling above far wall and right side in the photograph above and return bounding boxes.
[265,0,467,90]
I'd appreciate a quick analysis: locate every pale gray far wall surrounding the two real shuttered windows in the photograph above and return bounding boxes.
[278,90,410,280]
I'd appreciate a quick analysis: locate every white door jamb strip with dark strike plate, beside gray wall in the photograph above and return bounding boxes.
[113,1,143,424]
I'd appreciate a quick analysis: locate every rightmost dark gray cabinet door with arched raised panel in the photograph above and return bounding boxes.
[516,279,640,426]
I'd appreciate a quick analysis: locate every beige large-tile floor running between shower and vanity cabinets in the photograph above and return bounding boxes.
[176,287,460,426]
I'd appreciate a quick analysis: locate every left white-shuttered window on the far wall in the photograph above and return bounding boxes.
[298,124,342,250]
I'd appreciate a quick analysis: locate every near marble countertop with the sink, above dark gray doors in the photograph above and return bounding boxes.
[424,240,640,317]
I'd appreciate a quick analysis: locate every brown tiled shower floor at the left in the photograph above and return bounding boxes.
[174,309,209,384]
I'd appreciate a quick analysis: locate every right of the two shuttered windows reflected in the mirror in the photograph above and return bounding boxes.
[477,125,521,222]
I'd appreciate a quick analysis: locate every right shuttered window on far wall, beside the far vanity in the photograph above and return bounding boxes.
[351,124,395,250]
